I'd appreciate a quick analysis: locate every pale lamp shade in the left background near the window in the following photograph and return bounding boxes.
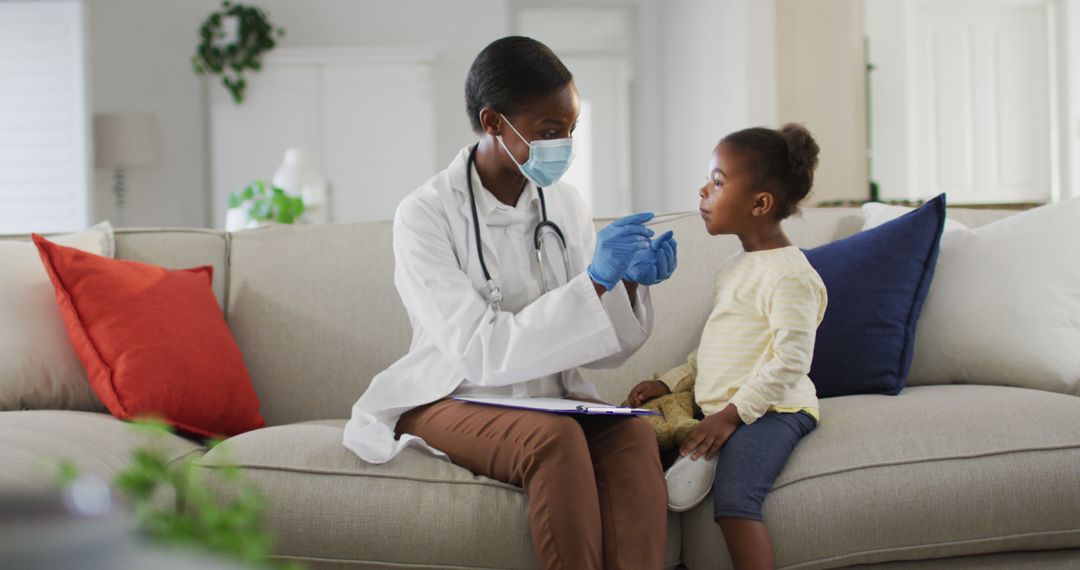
[94,113,161,168]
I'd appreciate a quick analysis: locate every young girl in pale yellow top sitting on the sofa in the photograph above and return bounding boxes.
[629,124,826,569]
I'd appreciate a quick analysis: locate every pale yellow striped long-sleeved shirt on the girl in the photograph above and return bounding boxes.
[660,246,828,424]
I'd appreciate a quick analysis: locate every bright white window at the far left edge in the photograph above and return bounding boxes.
[0,1,90,233]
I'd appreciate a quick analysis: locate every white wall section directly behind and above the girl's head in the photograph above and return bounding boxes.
[638,0,778,212]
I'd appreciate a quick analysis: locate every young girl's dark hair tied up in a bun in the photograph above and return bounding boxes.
[720,123,820,219]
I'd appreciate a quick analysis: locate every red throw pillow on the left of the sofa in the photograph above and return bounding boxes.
[33,235,265,436]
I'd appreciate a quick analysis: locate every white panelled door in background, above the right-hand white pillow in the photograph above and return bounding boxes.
[907,0,1053,203]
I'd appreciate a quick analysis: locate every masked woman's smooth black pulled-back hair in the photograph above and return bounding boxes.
[465,36,573,134]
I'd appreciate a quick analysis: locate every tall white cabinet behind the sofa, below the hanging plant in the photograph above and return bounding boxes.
[210,49,435,228]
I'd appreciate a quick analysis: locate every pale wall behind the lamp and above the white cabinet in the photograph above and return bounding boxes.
[86,0,508,227]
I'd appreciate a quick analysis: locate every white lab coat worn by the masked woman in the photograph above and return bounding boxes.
[343,148,652,463]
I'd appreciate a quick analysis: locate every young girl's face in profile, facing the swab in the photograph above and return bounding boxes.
[698,143,755,235]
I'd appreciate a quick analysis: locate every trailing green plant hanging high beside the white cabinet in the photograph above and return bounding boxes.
[191,0,285,105]
